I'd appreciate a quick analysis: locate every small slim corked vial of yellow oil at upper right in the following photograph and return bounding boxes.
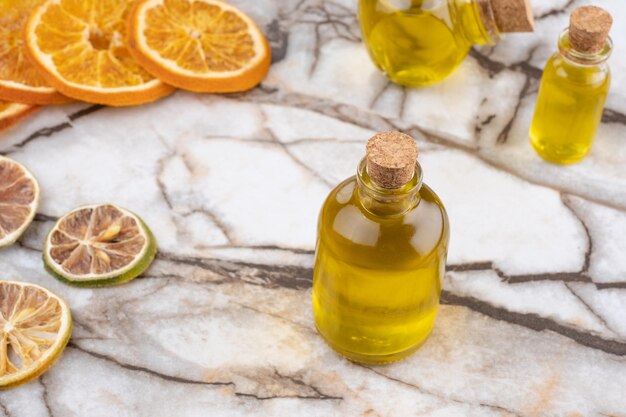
[530,6,613,164]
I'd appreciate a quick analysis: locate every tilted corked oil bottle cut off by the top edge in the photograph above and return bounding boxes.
[359,0,534,86]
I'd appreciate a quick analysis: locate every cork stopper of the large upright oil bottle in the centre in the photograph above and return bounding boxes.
[366,132,417,188]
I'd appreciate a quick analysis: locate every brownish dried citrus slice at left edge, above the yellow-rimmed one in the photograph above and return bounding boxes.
[0,156,39,247]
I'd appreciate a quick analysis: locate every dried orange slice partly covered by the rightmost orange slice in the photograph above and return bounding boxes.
[25,0,173,106]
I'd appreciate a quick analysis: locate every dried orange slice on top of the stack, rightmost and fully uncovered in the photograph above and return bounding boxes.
[129,0,271,92]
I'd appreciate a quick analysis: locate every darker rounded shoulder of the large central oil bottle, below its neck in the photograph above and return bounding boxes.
[319,177,449,260]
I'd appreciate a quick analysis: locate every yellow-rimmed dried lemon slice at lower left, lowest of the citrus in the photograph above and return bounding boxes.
[0,281,72,388]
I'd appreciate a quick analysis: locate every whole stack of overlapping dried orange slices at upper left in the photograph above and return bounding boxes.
[0,0,271,129]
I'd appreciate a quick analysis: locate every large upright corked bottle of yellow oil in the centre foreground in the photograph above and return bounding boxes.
[313,132,449,364]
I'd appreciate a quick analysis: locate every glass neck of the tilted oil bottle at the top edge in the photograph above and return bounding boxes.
[453,0,501,45]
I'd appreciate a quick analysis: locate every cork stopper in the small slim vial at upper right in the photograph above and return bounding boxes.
[569,6,613,54]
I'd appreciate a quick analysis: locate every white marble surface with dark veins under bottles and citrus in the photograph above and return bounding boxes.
[0,0,626,417]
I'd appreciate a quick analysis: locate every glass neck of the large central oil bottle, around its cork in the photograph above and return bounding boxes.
[356,159,422,216]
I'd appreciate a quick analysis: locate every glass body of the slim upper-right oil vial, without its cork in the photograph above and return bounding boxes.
[530,32,611,164]
